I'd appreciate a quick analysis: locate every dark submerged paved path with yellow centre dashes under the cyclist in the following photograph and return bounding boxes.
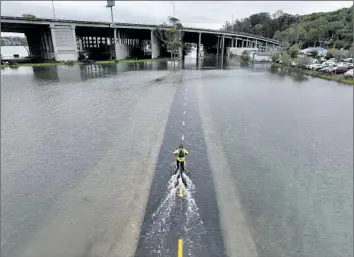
[136,70,225,257]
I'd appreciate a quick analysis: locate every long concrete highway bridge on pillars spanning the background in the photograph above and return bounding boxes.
[1,16,281,61]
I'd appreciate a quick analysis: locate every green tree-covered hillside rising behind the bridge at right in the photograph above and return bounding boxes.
[222,6,353,49]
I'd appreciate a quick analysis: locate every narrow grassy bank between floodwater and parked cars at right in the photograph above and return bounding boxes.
[272,63,354,86]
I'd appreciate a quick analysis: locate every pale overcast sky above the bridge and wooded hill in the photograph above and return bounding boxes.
[1,1,353,36]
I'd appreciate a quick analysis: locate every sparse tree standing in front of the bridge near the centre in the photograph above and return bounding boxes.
[154,17,184,60]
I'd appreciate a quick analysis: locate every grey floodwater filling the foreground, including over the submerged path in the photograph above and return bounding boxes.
[1,60,353,257]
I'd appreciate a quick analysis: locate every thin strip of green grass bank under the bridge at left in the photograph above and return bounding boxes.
[0,58,170,68]
